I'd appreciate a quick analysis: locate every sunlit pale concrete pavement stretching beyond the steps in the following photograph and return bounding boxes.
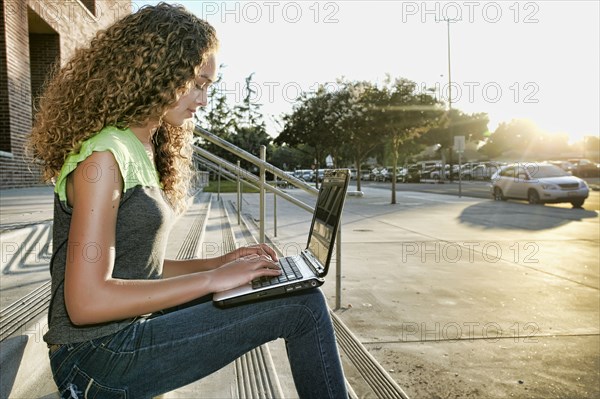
[0,187,600,398]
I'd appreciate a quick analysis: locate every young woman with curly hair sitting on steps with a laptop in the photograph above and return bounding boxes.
[29,3,347,398]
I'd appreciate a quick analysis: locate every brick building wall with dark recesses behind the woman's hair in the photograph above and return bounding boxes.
[0,0,131,188]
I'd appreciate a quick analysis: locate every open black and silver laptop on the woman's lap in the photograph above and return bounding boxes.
[213,169,350,307]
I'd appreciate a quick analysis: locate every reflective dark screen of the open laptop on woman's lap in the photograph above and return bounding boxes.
[307,169,349,273]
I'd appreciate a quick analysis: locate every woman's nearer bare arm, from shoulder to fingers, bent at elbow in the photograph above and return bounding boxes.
[65,152,281,325]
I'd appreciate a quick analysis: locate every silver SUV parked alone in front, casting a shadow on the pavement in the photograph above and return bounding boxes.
[491,163,589,208]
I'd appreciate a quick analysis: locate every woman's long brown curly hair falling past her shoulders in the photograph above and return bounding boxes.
[27,3,218,209]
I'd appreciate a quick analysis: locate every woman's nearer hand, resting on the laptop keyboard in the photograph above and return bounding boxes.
[207,255,281,292]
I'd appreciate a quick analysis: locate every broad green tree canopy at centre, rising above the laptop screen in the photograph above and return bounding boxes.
[275,79,442,194]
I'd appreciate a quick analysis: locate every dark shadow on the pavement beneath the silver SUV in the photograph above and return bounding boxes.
[458,201,598,231]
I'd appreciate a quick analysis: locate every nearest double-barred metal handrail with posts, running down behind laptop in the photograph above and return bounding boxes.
[193,125,342,309]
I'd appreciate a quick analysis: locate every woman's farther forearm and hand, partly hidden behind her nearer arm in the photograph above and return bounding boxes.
[163,244,277,278]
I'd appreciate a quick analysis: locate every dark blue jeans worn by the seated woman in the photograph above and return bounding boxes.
[50,289,348,399]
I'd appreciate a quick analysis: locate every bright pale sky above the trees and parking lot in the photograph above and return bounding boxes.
[137,0,600,142]
